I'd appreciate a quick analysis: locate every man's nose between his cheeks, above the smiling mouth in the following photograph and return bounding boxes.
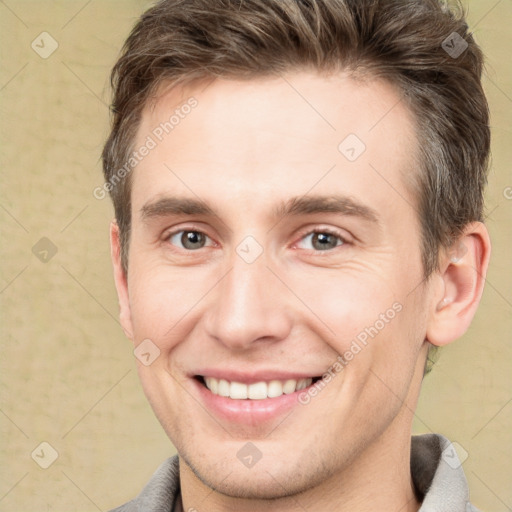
[203,248,292,350]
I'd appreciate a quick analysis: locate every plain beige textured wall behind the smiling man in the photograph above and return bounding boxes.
[0,0,512,512]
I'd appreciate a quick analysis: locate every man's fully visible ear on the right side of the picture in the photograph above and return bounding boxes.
[426,222,491,346]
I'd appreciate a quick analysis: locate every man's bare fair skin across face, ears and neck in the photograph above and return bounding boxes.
[111,72,490,512]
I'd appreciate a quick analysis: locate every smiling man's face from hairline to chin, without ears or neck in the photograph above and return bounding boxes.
[121,73,430,497]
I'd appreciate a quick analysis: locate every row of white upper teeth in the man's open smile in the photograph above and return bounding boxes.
[204,377,313,400]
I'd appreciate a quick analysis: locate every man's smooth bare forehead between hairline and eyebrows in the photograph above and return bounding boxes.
[133,72,416,216]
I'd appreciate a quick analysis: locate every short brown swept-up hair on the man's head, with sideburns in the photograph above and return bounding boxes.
[102,0,490,277]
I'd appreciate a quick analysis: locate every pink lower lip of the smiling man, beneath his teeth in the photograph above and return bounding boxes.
[192,379,314,426]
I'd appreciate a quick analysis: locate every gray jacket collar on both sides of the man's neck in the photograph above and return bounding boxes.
[111,434,478,512]
